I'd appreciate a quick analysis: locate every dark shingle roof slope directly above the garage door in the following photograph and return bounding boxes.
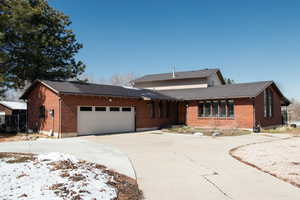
[41,81,172,99]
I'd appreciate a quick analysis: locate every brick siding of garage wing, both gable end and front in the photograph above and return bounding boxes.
[27,84,177,137]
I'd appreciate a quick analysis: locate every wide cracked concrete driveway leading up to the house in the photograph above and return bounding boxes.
[83,132,300,200]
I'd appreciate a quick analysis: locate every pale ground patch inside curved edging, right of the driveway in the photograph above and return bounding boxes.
[232,137,300,186]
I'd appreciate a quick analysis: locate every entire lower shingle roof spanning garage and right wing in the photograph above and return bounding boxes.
[21,80,290,105]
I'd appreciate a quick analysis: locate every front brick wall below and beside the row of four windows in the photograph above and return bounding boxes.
[187,98,254,128]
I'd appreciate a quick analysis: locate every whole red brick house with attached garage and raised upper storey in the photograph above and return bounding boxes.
[21,69,290,137]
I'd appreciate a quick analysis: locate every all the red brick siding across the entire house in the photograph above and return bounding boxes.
[26,83,282,135]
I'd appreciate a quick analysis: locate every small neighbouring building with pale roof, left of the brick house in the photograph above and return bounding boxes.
[0,101,27,132]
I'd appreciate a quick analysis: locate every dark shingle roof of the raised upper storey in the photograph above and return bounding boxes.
[133,69,219,83]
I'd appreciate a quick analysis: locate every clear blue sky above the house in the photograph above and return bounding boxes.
[50,0,300,99]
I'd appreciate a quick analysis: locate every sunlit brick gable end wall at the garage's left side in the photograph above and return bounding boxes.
[27,83,59,133]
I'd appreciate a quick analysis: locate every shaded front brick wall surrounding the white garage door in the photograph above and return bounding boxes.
[62,95,176,133]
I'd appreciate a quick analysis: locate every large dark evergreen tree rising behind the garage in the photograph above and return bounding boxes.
[0,0,85,90]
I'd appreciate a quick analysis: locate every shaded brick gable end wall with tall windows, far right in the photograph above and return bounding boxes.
[255,86,282,127]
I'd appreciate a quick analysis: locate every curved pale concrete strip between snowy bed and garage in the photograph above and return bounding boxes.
[0,138,136,179]
